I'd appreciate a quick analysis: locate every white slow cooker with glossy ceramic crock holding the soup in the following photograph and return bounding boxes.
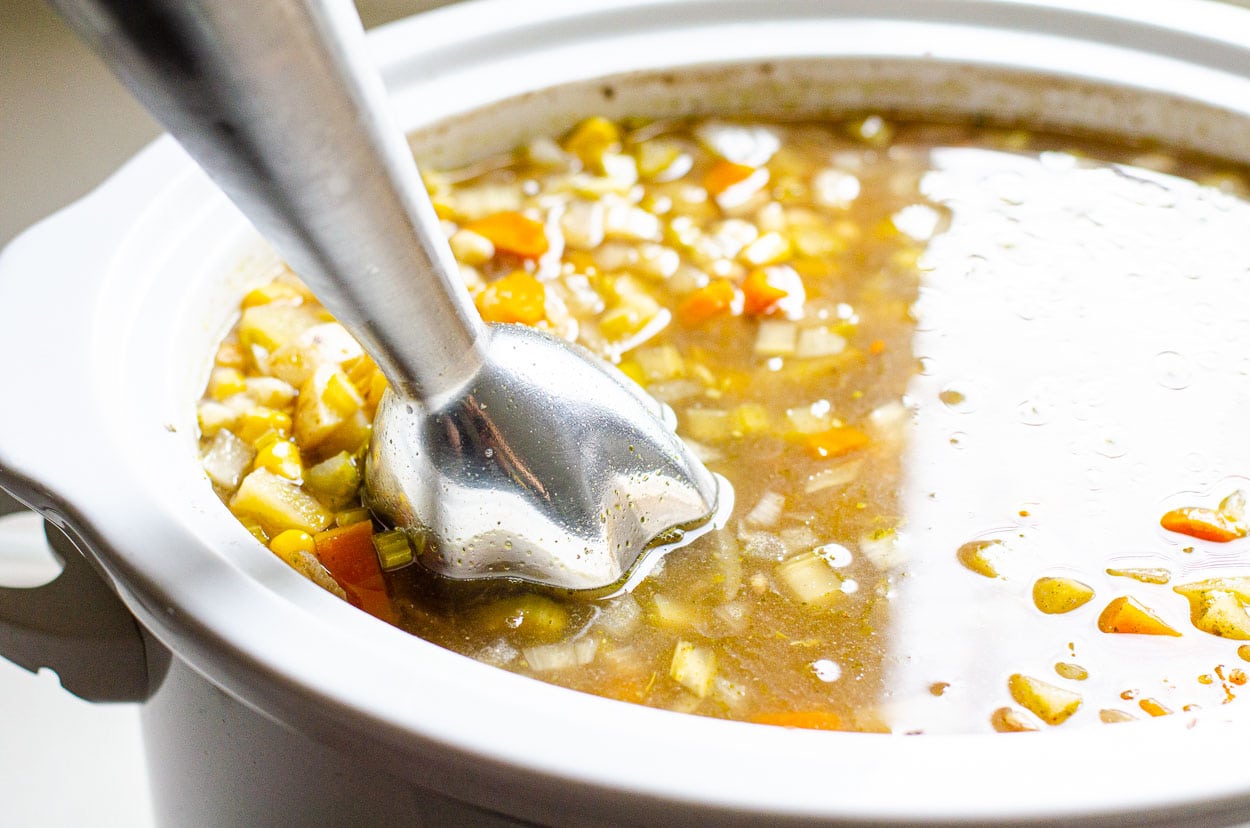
[0,0,1250,825]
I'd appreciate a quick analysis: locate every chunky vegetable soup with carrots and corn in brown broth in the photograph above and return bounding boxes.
[199,115,1250,732]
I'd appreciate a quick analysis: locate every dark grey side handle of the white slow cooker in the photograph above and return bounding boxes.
[0,489,149,702]
